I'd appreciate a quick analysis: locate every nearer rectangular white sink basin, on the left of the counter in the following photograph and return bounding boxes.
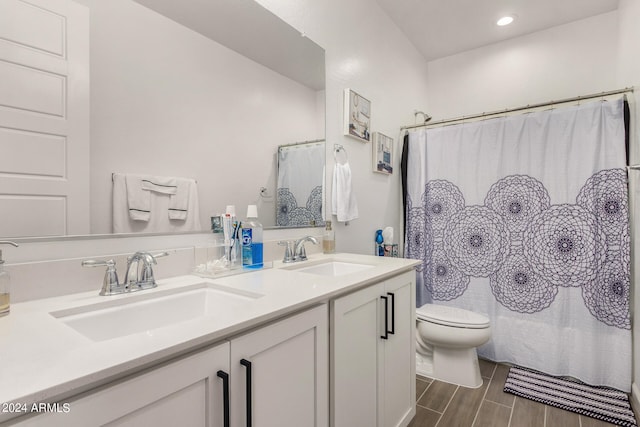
[50,283,262,341]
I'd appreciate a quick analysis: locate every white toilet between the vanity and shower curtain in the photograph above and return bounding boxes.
[416,304,491,388]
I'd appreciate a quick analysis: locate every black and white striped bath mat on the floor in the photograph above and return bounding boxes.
[504,366,637,427]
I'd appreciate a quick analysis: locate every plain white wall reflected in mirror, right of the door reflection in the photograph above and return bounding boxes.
[84,0,324,234]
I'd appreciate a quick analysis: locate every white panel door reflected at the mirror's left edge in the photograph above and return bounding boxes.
[0,0,90,237]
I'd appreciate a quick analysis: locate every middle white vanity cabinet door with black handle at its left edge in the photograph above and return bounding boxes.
[231,305,329,427]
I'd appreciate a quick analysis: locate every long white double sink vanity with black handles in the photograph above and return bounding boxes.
[0,254,417,427]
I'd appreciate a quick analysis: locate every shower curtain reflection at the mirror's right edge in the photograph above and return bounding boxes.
[276,141,325,227]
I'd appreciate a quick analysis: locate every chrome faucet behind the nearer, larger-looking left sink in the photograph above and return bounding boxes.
[82,252,169,295]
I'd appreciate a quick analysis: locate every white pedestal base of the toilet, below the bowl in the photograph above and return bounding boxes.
[416,347,482,388]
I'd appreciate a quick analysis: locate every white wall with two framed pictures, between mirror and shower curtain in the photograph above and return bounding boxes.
[257,0,427,254]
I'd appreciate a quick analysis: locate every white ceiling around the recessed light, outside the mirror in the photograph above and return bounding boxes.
[376,0,618,61]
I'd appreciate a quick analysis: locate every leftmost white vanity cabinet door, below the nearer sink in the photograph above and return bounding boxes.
[11,343,229,427]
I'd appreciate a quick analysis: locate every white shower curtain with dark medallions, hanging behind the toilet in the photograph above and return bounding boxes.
[405,98,631,392]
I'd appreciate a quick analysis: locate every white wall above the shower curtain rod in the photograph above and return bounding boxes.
[428,12,619,121]
